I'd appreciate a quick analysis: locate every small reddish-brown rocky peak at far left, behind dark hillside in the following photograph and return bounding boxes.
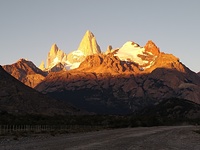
[3,59,47,88]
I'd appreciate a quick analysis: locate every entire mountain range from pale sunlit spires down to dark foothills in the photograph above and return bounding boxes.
[0,31,200,117]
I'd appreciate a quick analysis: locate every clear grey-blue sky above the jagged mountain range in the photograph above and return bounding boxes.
[0,0,200,72]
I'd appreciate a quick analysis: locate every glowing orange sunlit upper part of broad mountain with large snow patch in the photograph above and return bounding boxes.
[76,40,185,74]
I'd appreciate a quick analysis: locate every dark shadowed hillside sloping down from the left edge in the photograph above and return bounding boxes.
[0,66,78,115]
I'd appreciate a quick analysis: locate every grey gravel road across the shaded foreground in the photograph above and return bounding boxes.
[0,126,200,150]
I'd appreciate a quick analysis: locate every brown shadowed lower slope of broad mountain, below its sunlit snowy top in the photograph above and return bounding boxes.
[36,68,200,114]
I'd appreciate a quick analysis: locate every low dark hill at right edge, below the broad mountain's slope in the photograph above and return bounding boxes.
[139,98,200,121]
